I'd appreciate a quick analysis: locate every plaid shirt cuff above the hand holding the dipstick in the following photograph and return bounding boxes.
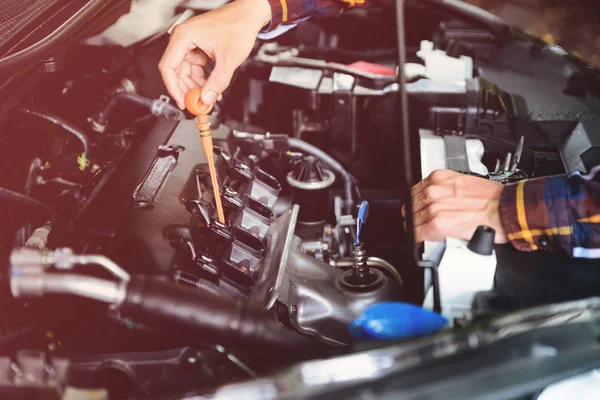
[262,0,371,32]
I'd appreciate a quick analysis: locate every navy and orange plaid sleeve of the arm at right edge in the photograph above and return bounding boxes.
[500,166,600,258]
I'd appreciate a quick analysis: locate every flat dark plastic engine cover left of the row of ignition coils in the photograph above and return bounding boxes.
[68,120,229,274]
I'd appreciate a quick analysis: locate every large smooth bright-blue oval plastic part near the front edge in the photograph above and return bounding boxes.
[349,302,448,340]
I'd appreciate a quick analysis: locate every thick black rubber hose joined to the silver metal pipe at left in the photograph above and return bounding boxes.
[119,276,329,359]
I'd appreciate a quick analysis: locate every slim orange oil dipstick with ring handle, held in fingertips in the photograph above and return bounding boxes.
[185,88,225,224]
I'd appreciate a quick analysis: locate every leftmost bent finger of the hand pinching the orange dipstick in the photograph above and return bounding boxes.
[158,30,193,109]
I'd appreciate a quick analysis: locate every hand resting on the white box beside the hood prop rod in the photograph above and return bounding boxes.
[402,170,508,243]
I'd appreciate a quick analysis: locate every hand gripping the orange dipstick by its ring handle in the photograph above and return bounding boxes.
[158,0,271,110]
